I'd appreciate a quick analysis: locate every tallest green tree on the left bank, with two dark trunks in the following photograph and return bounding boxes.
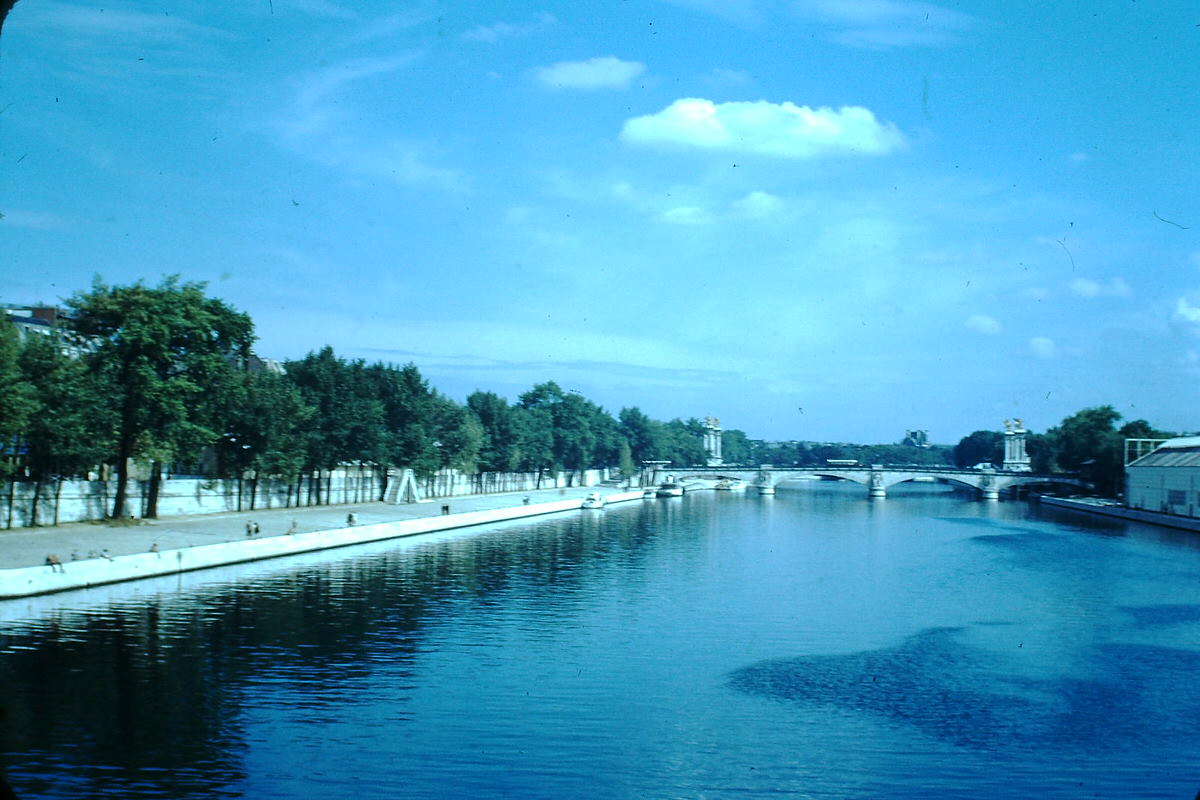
[67,276,253,517]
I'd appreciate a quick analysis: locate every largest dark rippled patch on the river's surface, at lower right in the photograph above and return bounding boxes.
[730,628,1200,756]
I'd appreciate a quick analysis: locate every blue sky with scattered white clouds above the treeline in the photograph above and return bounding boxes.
[0,0,1200,444]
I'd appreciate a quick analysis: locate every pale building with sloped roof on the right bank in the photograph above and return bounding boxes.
[1126,437,1200,517]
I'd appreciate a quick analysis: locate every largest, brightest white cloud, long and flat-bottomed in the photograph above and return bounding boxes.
[620,97,904,158]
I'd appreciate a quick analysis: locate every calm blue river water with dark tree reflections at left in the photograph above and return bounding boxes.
[0,483,1200,800]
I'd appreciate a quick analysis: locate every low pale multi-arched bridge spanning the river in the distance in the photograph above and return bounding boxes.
[650,464,1088,500]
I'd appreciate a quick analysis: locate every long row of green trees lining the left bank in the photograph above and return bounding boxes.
[0,277,749,517]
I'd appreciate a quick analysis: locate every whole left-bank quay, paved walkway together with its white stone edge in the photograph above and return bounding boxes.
[0,487,642,600]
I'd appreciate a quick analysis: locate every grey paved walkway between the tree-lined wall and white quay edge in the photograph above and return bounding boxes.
[0,487,612,570]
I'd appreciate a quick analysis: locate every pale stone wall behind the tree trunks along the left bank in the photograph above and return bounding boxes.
[0,468,607,529]
